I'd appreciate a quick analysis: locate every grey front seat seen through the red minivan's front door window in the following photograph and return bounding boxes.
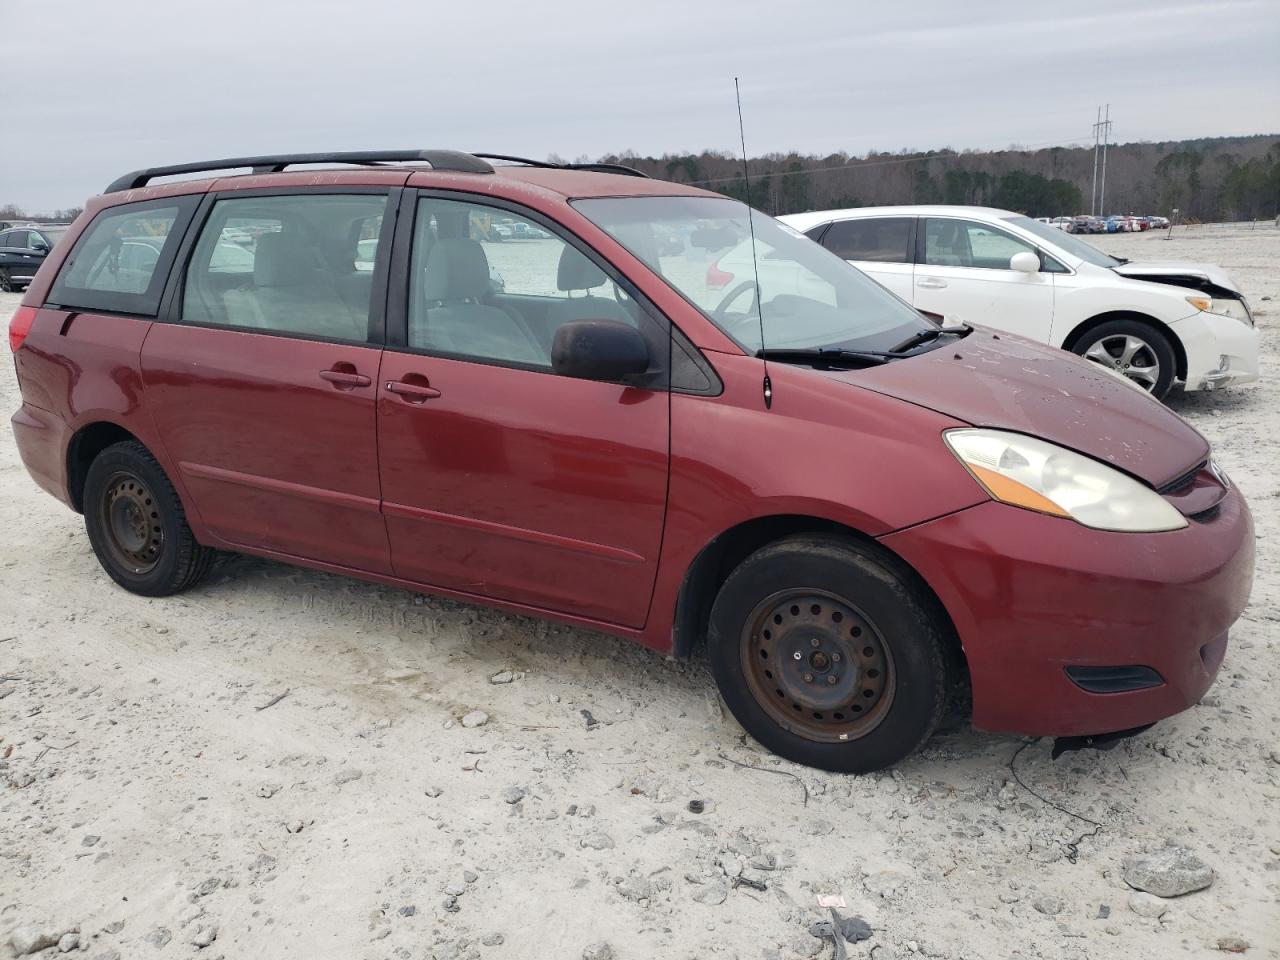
[408,237,550,366]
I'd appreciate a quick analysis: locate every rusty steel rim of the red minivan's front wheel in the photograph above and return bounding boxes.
[741,589,897,744]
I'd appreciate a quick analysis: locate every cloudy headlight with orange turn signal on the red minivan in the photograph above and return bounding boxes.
[942,429,1187,534]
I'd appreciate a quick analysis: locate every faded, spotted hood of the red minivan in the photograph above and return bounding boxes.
[828,328,1210,489]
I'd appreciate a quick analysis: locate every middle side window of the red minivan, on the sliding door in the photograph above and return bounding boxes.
[182,193,387,342]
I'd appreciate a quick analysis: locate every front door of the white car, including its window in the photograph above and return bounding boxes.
[911,216,1053,343]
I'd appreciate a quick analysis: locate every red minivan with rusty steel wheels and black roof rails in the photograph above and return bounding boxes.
[9,151,1253,772]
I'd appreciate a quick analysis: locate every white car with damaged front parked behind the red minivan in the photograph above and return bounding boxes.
[778,206,1258,398]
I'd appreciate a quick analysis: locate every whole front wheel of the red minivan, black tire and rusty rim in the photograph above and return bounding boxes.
[708,535,950,773]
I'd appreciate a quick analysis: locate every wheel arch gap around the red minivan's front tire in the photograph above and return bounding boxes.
[672,515,969,690]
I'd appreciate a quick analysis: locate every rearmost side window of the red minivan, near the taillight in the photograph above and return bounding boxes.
[49,197,198,316]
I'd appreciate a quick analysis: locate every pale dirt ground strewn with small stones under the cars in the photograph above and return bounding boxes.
[0,227,1280,960]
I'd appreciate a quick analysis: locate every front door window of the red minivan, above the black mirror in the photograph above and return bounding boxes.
[407,197,668,370]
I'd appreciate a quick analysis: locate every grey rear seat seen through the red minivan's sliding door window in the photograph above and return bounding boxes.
[223,230,369,340]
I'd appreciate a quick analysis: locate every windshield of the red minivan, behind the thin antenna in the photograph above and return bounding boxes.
[573,197,936,353]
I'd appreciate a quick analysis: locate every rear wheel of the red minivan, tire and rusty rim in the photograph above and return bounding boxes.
[84,440,216,596]
